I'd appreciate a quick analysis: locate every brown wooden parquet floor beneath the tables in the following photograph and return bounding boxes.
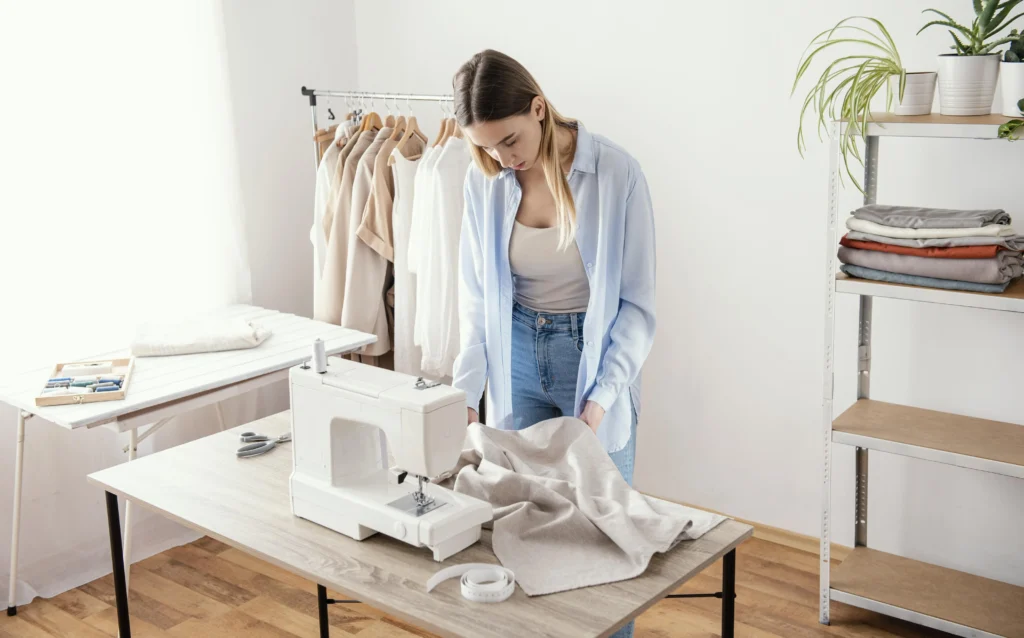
[0,539,946,638]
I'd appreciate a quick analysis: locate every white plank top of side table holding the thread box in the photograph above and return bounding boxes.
[0,305,376,429]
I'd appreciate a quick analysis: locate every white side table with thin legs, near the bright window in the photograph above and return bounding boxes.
[0,305,376,615]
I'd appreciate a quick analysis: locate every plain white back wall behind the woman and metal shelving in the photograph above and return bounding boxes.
[355,0,1024,584]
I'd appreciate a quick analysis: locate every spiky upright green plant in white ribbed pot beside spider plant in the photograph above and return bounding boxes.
[918,0,1024,116]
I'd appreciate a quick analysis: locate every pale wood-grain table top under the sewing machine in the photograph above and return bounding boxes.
[89,412,753,637]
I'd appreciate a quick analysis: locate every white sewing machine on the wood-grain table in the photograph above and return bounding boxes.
[290,358,493,561]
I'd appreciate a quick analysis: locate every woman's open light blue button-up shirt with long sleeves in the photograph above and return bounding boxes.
[453,124,654,452]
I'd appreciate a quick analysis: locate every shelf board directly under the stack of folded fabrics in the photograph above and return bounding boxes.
[836,272,1024,312]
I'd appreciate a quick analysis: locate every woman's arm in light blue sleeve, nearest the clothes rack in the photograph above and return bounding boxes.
[453,177,487,422]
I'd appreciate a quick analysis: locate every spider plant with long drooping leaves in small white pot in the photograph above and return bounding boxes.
[791,15,921,192]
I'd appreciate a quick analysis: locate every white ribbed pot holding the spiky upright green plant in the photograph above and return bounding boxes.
[939,53,999,115]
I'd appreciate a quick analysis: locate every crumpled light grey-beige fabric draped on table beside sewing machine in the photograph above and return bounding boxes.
[441,417,725,596]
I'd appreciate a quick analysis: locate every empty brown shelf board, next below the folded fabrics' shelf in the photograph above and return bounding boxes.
[833,398,1024,478]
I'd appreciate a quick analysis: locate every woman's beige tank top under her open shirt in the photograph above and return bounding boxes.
[509,221,590,313]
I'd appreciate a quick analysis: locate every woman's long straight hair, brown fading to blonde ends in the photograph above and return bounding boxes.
[453,49,577,250]
